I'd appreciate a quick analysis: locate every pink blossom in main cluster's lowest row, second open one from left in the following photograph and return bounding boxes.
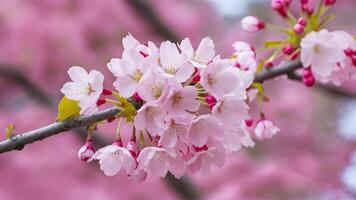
[137,147,186,178]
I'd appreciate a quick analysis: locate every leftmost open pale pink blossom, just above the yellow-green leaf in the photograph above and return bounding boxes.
[61,66,104,114]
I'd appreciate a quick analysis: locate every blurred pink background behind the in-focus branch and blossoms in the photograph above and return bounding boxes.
[0,0,356,200]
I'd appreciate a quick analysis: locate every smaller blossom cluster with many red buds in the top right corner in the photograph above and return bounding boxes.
[241,0,356,87]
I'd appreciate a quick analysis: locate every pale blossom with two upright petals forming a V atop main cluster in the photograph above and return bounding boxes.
[179,37,215,68]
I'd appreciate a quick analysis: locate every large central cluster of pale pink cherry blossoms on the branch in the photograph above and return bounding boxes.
[61,34,279,181]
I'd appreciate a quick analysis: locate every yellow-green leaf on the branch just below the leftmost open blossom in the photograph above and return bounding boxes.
[57,96,80,121]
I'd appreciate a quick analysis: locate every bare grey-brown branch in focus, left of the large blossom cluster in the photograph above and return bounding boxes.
[0,108,120,153]
